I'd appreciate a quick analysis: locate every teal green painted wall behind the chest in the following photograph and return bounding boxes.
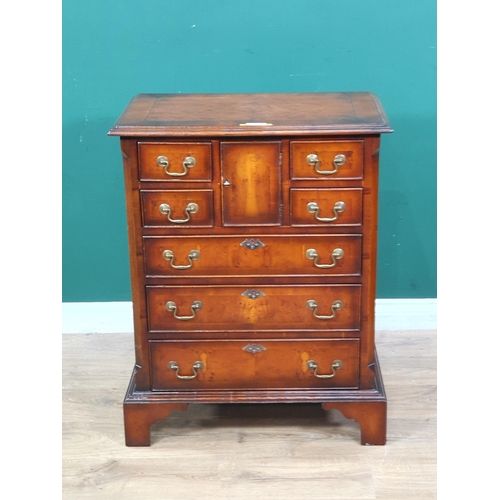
[63,0,436,302]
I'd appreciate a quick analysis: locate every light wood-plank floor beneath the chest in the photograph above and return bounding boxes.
[62,330,436,500]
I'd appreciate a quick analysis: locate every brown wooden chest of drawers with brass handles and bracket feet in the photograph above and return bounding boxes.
[109,92,391,446]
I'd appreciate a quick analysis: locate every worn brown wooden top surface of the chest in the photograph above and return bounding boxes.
[109,92,392,137]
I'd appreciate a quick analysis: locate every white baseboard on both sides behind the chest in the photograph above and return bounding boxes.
[62,299,437,333]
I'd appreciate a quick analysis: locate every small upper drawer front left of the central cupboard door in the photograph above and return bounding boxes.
[139,142,212,182]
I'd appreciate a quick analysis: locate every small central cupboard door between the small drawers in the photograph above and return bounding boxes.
[221,141,281,226]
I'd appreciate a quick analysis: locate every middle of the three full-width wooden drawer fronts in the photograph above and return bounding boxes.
[146,285,361,332]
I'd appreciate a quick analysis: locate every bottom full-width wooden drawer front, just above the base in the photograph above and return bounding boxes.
[150,339,359,391]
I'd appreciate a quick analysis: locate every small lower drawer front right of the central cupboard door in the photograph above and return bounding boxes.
[290,188,363,226]
